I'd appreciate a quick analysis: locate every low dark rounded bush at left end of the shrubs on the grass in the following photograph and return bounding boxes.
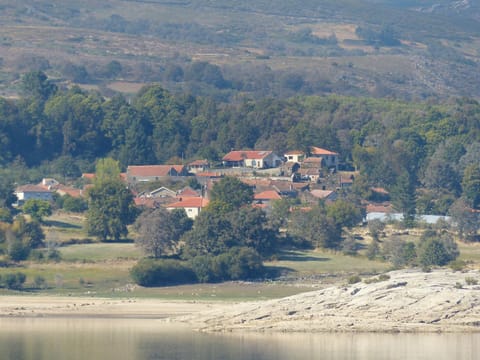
[130,259,197,286]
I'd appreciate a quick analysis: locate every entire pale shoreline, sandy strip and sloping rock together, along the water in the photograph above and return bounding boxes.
[0,269,480,333]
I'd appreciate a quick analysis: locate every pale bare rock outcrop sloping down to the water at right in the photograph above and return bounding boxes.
[176,270,480,332]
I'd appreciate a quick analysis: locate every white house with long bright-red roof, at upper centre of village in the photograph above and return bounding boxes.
[222,150,282,169]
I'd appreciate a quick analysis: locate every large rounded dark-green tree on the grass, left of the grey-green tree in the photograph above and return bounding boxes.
[86,180,137,241]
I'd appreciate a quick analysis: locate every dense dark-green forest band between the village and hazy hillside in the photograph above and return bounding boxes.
[0,72,480,213]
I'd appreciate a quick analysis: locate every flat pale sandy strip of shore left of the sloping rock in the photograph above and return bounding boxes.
[0,296,219,319]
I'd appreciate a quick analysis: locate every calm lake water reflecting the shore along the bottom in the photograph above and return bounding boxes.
[0,318,480,360]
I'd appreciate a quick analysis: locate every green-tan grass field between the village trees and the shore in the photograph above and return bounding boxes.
[0,213,480,301]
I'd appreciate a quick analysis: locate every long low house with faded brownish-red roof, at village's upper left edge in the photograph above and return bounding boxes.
[126,165,188,183]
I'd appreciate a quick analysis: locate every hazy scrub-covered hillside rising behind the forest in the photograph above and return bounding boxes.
[0,0,480,101]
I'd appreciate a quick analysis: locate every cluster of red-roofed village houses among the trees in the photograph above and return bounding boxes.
[16,147,392,219]
